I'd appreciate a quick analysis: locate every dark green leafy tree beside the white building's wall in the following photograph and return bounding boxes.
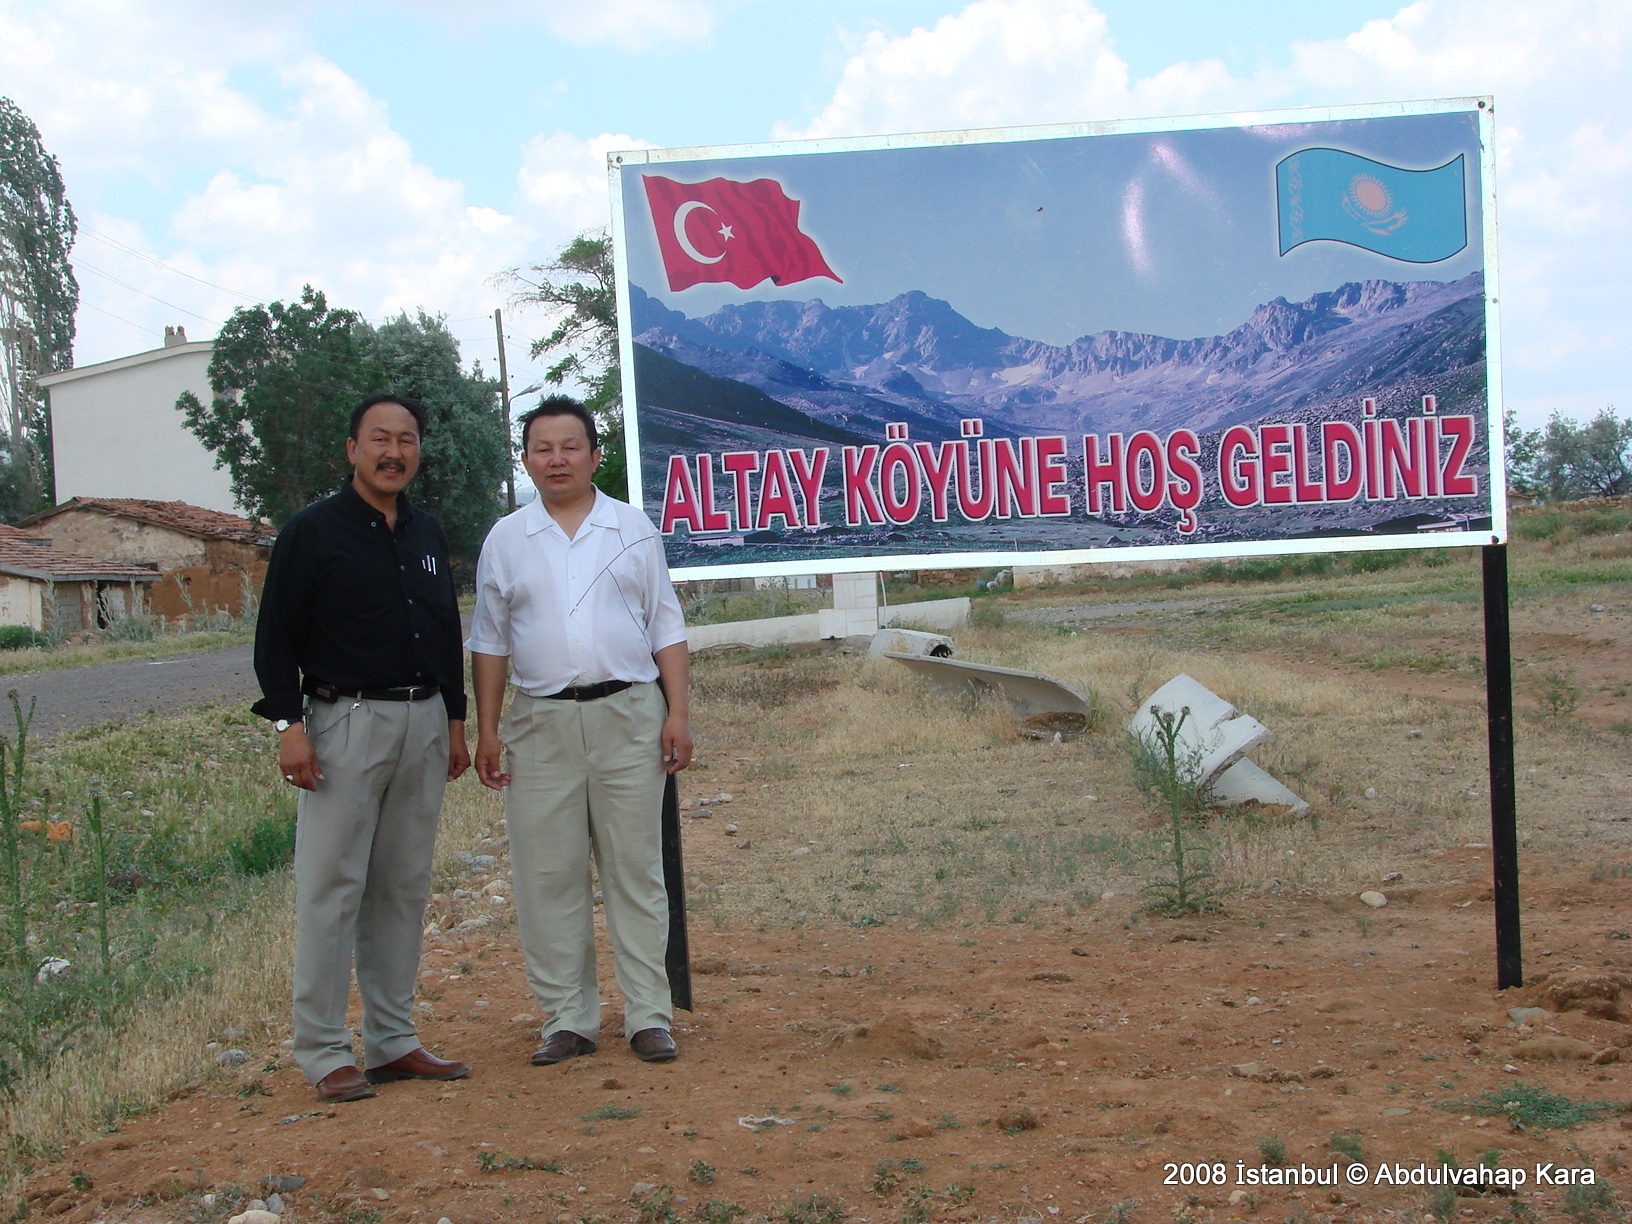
[176,286,373,527]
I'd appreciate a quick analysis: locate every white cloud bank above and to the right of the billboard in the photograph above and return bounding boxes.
[777,0,1632,424]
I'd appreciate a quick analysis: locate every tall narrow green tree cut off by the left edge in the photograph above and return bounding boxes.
[0,98,80,506]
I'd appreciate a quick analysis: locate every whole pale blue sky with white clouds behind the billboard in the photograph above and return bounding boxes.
[0,0,1632,423]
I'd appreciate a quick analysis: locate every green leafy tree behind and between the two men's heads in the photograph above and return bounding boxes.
[361,310,511,560]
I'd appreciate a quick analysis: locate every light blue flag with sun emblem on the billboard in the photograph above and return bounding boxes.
[1275,149,1467,263]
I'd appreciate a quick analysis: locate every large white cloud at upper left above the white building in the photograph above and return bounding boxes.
[0,0,539,373]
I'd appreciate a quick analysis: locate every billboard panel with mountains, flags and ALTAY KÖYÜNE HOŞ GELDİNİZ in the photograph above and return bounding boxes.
[609,98,1506,578]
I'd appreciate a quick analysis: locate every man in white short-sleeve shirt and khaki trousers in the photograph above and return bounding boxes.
[467,397,692,1066]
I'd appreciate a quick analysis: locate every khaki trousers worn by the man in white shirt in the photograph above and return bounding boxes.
[501,684,674,1040]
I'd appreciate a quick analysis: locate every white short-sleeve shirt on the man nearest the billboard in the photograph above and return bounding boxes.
[465,490,685,697]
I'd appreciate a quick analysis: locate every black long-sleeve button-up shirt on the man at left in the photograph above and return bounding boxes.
[251,480,465,721]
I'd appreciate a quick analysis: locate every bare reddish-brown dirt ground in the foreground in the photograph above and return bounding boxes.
[12,610,1632,1224]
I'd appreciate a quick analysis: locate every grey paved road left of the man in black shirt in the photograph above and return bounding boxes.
[0,646,259,741]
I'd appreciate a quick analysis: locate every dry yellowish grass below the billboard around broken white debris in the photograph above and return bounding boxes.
[694,590,1624,927]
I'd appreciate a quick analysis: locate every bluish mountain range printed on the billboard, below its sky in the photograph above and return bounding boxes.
[630,273,1488,565]
